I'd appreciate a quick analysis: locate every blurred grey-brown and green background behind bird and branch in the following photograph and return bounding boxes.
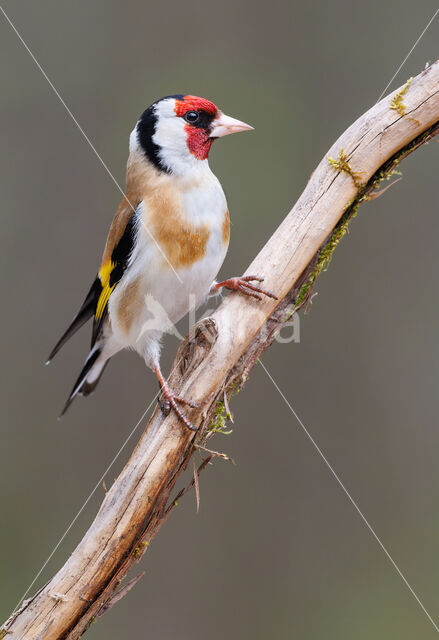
[0,0,439,640]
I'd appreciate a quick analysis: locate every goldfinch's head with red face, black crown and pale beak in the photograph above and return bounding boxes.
[130,95,253,175]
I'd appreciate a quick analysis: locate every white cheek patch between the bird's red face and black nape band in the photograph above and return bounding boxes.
[152,98,207,175]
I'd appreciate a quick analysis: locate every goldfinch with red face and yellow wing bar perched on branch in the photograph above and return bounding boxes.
[47,94,276,431]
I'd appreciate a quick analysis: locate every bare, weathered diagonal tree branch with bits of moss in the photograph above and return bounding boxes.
[0,62,439,640]
